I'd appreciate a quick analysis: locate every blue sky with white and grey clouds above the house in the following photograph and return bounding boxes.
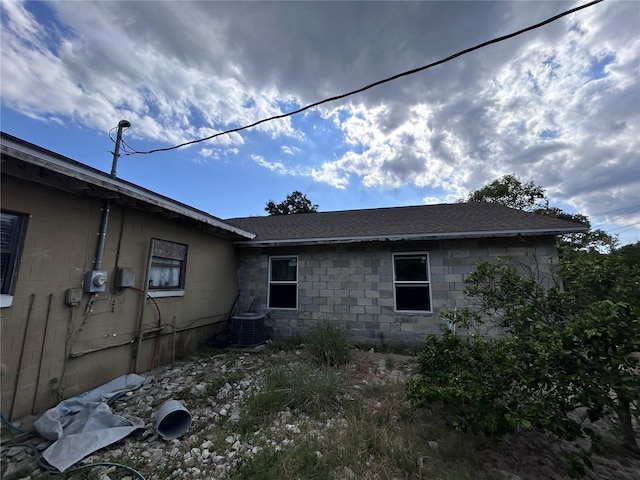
[0,0,640,244]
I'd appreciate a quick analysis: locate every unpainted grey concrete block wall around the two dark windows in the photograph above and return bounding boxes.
[239,237,556,344]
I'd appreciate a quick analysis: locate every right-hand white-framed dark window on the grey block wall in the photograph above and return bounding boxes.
[393,253,431,312]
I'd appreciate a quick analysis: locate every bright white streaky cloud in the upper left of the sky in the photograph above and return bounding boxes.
[2,2,296,143]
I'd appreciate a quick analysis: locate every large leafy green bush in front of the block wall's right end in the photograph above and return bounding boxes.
[407,259,640,464]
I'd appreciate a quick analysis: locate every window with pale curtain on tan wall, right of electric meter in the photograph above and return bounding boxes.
[149,239,187,296]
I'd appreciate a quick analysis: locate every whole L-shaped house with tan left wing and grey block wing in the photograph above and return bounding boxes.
[0,133,585,419]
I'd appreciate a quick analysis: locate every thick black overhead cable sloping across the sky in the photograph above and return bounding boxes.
[126,0,603,155]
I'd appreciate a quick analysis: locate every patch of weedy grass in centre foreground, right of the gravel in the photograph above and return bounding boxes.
[232,348,496,480]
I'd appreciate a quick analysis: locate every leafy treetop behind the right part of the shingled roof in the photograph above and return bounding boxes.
[466,174,547,211]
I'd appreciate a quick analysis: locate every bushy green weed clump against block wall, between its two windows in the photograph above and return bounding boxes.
[307,322,351,366]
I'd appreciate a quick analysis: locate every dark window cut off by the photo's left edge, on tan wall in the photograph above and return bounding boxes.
[0,210,27,307]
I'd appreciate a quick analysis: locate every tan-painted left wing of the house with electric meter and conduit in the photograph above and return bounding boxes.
[0,133,253,418]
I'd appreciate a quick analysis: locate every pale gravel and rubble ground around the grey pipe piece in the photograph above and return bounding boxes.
[2,350,416,480]
